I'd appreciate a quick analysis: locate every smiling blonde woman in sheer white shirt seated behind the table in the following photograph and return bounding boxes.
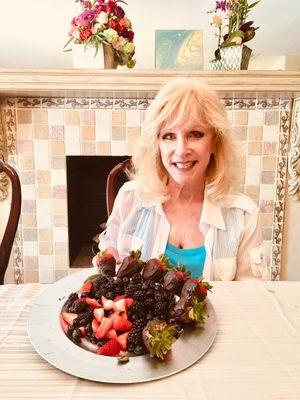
[99,78,266,280]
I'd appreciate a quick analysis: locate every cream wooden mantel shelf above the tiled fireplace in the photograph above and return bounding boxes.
[0,69,300,97]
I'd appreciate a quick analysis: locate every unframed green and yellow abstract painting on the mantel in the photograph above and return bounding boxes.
[155,29,203,71]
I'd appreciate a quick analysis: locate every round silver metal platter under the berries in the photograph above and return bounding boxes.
[28,268,217,383]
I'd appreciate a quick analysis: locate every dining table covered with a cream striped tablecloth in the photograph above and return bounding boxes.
[0,280,300,400]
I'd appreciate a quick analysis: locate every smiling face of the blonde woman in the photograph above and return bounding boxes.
[158,120,214,186]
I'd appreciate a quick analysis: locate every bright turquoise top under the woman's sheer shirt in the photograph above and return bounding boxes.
[165,242,206,278]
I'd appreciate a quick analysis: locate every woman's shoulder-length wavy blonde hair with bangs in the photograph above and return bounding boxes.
[128,78,237,203]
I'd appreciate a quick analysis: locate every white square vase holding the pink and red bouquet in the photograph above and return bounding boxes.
[72,44,118,69]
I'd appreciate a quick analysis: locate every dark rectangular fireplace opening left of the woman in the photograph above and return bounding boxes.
[67,156,128,268]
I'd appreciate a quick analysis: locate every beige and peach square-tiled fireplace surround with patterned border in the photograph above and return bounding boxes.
[0,92,291,283]
